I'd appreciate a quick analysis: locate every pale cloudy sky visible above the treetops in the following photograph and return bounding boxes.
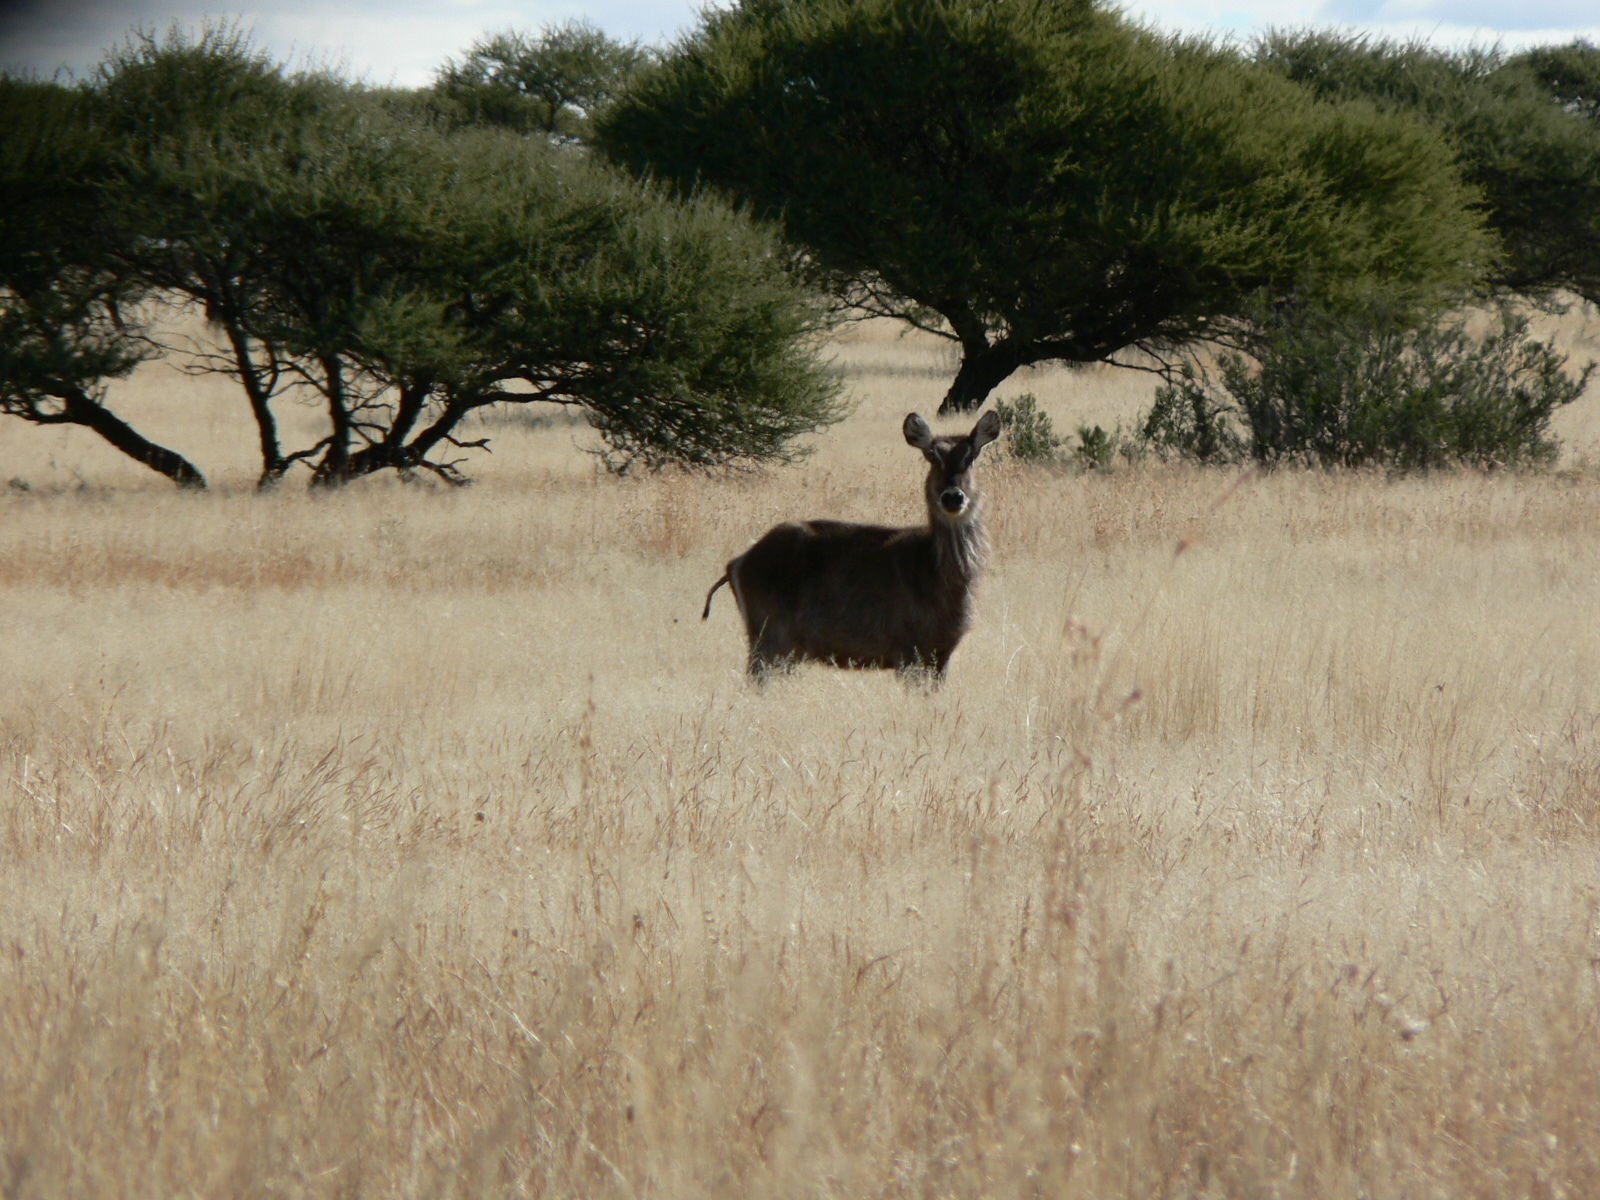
[0,0,1600,86]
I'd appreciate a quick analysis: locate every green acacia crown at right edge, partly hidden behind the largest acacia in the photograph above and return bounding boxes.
[1254,32,1600,312]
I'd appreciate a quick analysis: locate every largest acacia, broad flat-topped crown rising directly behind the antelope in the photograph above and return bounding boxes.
[595,0,1490,411]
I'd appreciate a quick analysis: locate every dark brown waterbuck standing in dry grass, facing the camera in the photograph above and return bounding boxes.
[701,413,1000,682]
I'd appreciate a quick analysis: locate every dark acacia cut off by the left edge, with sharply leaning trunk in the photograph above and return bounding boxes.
[0,78,205,488]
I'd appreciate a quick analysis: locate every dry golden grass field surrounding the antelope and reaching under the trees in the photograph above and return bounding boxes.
[0,317,1600,1200]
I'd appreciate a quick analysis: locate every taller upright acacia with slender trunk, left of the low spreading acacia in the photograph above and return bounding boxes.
[79,27,432,485]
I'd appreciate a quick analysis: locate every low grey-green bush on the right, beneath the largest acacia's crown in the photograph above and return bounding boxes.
[1142,298,1594,470]
